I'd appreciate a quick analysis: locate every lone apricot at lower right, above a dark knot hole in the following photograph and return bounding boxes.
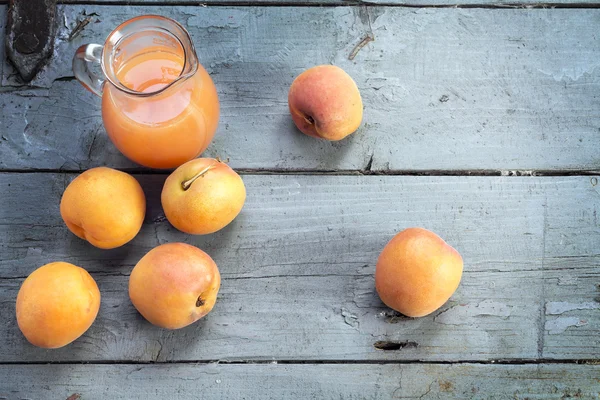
[375,228,463,317]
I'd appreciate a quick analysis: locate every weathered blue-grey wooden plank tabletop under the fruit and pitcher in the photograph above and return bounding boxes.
[0,0,600,400]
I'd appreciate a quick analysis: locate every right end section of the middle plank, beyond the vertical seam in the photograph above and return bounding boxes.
[543,177,600,358]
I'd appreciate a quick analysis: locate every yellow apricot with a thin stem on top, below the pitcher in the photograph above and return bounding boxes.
[161,158,246,235]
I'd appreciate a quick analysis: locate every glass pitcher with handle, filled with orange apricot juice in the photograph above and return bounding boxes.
[73,15,219,168]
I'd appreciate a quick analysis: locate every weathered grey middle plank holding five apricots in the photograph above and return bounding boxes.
[0,173,600,362]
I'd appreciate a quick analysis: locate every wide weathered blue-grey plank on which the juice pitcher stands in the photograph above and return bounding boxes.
[0,5,600,170]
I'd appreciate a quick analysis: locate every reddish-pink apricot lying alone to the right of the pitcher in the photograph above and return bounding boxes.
[288,65,363,140]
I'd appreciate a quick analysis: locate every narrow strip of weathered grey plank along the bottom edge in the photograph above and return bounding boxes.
[0,364,600,400]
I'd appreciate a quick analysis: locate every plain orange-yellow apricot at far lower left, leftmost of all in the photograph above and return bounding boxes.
[16,262,100,349]
